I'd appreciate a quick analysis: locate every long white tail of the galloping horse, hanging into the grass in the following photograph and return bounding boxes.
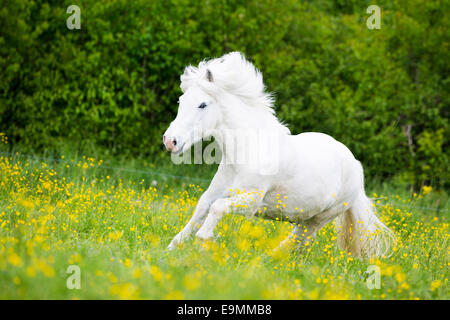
[336,191,396,258]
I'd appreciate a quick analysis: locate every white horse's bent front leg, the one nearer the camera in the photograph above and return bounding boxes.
[195,192,262,240]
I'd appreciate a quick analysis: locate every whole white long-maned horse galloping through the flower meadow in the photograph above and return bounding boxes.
[163,52,395,257]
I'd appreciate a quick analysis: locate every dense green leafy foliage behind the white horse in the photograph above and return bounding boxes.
[0,0,450,187]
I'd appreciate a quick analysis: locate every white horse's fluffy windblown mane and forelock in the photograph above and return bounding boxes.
[181,52,275,114]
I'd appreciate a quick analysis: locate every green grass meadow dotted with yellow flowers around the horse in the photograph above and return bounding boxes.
[0,150,450,299]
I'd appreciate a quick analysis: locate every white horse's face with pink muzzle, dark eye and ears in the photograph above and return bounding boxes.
[163,70,221,154]
